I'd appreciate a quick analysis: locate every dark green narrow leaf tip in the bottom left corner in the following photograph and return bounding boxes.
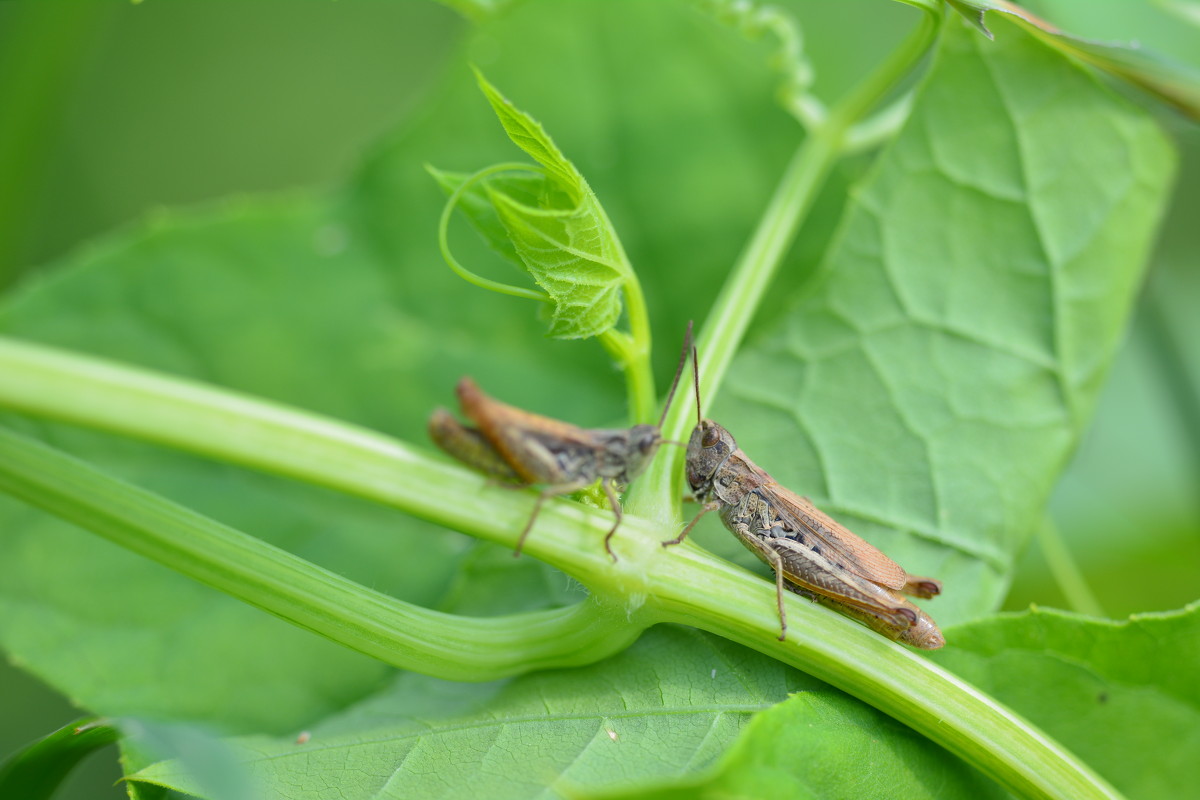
[0,717,120,800]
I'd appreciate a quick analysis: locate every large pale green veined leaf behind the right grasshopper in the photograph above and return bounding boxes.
[714,10,1174,624]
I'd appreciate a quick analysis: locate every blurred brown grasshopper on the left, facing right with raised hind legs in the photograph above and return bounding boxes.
[428,323,691,563]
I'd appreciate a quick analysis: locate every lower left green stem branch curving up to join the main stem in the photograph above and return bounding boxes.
[0,428,638,681]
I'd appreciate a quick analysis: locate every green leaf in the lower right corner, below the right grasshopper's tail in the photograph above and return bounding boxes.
[931,604,1200,800]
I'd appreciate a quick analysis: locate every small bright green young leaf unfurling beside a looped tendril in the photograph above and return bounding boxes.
[431,69,632,338]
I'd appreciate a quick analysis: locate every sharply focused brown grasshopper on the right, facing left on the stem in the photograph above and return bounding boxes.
[662,350,946,650]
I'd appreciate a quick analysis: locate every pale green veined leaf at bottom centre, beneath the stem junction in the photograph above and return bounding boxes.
[131,626,859,800]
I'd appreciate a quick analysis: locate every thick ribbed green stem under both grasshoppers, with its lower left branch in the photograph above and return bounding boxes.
[0,338,1117,800]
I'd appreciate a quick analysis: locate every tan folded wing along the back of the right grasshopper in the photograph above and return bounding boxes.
[764,483,908,590]
